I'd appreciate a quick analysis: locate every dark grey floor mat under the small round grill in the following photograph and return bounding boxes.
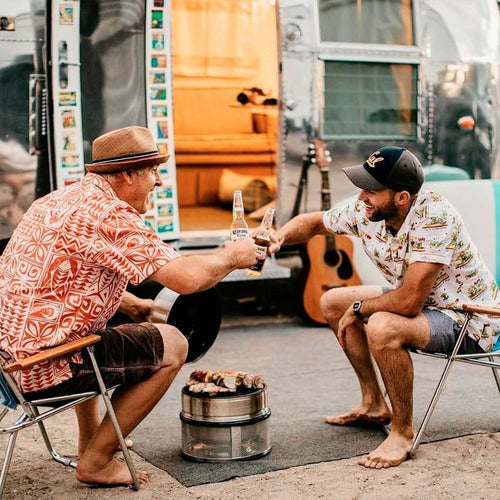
[132,324,500,486]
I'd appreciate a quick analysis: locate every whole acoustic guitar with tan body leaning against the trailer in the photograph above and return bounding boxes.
[302,140,361,324]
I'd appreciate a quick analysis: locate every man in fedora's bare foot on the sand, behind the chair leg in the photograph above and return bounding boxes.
[75,458,149,486]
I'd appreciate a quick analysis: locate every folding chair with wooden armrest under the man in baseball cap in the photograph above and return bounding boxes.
[410,305,500,455]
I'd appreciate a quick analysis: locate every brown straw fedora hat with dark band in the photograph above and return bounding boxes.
[85,126,169,174]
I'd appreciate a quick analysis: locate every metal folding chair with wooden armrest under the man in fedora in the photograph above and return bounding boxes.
[0,335,139,497]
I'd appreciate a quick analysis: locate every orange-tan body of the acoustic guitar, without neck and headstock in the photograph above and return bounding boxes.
[302,236,361,324]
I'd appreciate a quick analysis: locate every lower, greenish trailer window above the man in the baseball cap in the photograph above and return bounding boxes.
[323,61,417,139]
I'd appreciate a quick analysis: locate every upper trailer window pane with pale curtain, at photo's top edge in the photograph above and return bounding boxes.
[318,0,414,45]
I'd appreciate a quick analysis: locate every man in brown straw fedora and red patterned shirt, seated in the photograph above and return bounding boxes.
[0,126,256,485]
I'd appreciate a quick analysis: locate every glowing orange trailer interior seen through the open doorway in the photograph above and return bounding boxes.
[168,0,278,231]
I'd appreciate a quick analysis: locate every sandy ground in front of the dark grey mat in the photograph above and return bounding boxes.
[0,412,500,500]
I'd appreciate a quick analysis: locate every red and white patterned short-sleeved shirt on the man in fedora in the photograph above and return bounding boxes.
[0,173,179,392]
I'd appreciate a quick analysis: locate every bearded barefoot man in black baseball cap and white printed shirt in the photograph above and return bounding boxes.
[269,146,500,469]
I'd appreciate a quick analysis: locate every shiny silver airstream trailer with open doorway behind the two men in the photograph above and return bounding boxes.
[0,0,499,260]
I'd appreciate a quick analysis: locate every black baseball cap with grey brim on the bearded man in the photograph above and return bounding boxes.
[342,146,424,194]
